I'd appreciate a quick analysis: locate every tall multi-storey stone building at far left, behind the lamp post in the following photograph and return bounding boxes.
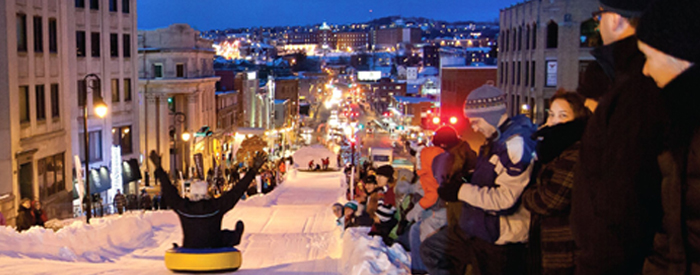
[0,0,139,224]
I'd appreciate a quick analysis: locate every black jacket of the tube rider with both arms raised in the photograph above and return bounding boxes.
[155,168,257,248]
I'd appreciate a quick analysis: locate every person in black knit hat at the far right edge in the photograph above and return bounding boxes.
[637,0,700,275]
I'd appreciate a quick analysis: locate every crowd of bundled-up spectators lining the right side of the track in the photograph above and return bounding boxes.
[333,0,700,274]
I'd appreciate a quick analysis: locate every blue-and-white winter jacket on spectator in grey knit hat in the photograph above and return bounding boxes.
[458,115,536,245]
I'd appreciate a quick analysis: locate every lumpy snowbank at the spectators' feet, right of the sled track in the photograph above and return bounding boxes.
[339,227,411,275]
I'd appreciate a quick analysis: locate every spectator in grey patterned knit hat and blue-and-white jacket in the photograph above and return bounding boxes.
[420,84,536,274]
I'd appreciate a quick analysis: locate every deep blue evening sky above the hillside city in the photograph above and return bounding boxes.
[138,0,522,30]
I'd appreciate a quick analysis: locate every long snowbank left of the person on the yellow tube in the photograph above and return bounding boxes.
[0,211,179,263]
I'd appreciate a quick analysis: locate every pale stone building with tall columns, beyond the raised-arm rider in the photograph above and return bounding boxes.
[138,24,219,179]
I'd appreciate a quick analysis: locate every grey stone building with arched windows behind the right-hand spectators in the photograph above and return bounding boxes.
[497,0,601,123]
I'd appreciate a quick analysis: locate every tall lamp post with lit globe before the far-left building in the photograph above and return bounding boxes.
[82,74,107,224]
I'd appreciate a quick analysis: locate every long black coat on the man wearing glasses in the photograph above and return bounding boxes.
[571,37,666,275]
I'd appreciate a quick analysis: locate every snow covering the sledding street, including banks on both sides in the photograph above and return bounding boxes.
[0,172,410,275]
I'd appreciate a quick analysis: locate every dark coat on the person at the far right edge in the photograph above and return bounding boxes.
[644,65,700,274]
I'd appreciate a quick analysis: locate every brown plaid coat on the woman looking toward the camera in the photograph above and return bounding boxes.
[522,119,587,274]
